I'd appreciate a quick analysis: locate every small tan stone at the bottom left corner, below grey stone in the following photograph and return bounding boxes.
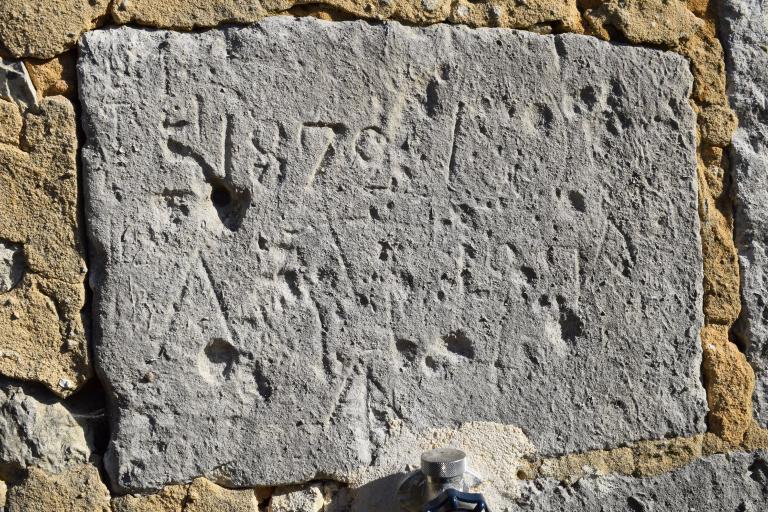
[8,464,110,512]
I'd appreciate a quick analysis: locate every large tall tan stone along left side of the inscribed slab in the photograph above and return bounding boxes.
[0,97,91,396]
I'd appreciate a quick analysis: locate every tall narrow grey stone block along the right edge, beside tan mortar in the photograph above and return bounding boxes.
[720,0,768,427]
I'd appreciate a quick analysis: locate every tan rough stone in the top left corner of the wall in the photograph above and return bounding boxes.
[0,0,110,59]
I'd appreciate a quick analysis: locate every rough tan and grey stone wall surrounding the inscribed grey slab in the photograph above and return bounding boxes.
[0,0,768,511]
